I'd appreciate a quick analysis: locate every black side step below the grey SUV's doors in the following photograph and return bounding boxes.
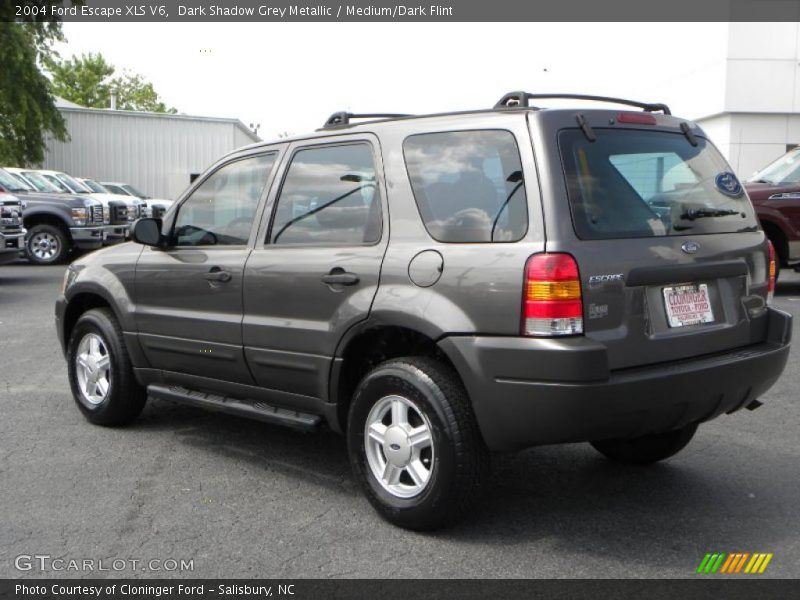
[147,383,322,431]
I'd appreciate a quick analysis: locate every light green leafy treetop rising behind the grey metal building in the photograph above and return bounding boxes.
[46,53,177,113]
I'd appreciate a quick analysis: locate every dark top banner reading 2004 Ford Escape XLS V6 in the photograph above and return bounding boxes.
[0,0,800,22]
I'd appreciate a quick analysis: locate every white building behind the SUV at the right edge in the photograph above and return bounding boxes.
[692,23,800,179]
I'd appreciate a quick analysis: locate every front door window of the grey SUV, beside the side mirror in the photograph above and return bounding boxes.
[174,153,276,246]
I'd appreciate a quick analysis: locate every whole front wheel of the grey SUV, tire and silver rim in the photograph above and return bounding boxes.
[67,308,147,427]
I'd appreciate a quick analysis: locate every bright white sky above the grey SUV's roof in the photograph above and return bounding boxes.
[57,23,728,139]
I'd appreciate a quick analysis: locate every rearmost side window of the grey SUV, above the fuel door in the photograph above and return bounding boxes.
[403,131,528,242]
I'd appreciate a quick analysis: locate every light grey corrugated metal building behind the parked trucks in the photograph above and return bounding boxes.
[43,99,260,199]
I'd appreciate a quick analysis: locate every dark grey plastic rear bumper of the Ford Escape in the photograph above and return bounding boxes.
[439,309,792,450]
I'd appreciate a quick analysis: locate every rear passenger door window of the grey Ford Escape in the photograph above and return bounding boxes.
[270,144,383,245]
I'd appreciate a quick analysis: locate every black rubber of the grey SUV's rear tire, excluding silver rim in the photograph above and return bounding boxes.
[347,357,489,531]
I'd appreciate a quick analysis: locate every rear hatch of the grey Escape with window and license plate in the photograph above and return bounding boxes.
[545,111,768,369]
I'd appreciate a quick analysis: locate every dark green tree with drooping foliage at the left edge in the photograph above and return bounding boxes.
[0,0,82,165]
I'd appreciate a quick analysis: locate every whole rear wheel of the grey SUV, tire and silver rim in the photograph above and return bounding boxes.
[347,357,489,531]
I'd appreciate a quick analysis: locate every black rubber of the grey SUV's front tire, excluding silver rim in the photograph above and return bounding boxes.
[67,308,147,427]
